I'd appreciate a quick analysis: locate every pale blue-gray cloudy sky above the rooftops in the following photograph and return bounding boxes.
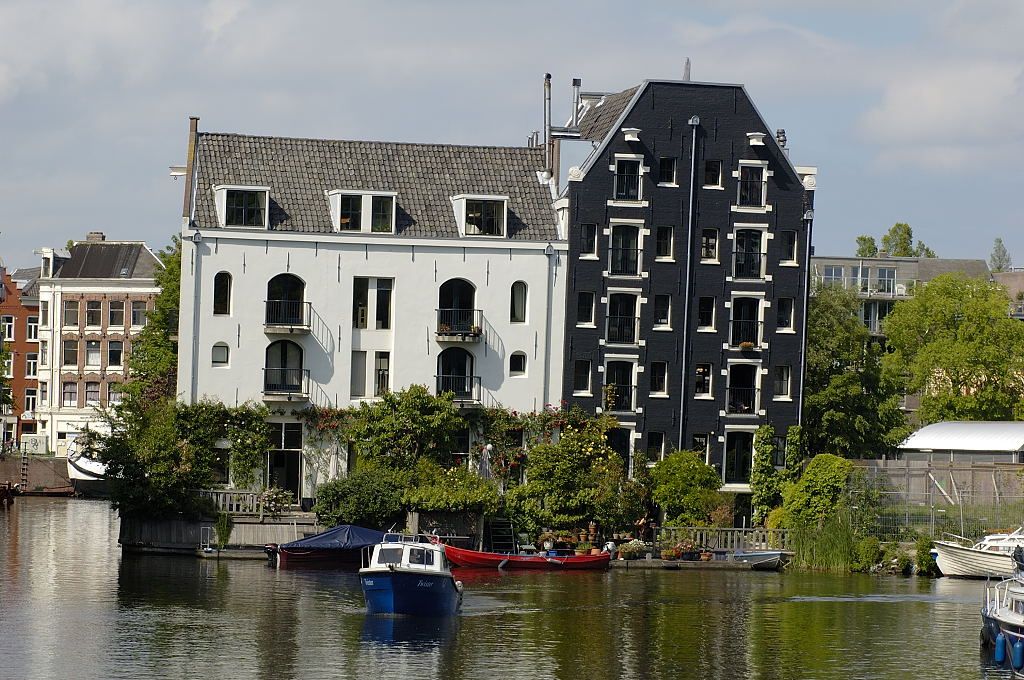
[0,0,1024,266]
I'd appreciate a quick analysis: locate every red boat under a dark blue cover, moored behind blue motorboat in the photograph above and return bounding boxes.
[263,524,384,571]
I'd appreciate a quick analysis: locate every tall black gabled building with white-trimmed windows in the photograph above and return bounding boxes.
[553,81,816,501]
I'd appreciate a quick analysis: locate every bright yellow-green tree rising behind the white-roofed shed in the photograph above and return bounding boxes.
[884,274,1024,423]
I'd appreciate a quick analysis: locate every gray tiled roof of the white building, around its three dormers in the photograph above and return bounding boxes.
[195,132,557,241]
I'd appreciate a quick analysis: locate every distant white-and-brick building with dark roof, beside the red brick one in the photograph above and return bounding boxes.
[36,231,163,456]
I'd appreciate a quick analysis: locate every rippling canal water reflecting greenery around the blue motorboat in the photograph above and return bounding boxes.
[0,498,1010,680]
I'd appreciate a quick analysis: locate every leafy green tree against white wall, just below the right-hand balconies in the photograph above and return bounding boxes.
[347,385,466,469]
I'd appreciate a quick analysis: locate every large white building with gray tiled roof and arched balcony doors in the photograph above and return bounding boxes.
[172,119,566,498]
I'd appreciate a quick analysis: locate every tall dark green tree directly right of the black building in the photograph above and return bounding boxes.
[803,286,906,458]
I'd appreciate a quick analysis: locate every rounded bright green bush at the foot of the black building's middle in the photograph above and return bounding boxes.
[651,451,722,526]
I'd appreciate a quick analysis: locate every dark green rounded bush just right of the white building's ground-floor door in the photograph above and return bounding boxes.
[313,463,410,529]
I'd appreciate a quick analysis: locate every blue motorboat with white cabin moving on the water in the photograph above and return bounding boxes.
[359,534,462,617]
